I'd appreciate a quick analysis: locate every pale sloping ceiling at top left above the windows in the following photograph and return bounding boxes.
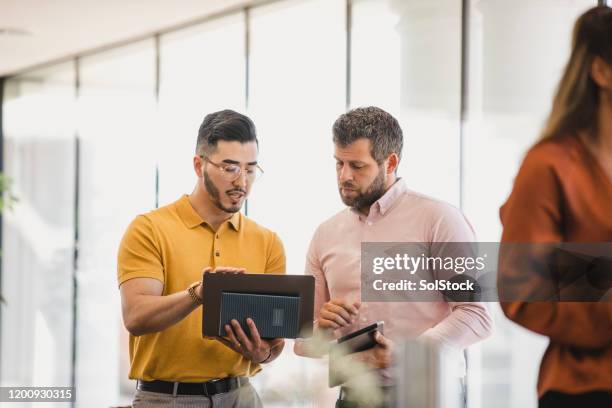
[0,0,262,76]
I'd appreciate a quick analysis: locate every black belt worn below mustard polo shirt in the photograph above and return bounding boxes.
[136,377,249,397]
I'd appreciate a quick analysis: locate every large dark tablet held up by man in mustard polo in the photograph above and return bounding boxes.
[202,272,314,339]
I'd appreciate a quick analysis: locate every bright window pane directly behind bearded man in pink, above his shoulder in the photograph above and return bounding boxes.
[351,0,461,206]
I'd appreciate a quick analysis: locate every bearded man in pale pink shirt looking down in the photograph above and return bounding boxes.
[295,107,492,407]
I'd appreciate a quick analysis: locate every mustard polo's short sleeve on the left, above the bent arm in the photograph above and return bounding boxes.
[117,215,165,286]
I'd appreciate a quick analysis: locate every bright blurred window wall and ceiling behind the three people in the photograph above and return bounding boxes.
[0,0,603,408]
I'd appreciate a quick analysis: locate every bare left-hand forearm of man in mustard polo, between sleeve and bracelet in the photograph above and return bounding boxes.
[125,290,197,336]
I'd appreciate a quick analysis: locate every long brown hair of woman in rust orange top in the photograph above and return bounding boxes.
[541,6,612,139]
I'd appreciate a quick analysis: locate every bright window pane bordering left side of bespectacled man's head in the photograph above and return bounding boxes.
[157,13,246,205]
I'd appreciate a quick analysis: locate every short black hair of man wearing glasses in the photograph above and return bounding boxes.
[196,109,259,154]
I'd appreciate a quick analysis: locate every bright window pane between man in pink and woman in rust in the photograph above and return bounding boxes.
[462,0,595,407]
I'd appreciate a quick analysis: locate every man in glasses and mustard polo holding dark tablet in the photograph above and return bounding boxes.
[118,110,285,408]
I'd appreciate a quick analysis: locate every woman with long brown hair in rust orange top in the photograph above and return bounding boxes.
[499,6,612,408]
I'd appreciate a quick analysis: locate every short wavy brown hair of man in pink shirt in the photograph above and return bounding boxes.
[333,106,404,164]
